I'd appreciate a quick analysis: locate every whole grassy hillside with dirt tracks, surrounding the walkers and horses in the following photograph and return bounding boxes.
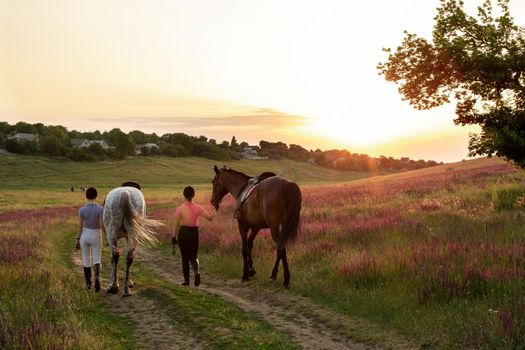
[0,157,525,349]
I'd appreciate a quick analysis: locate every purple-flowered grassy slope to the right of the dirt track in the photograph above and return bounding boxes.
[154,159,525,349]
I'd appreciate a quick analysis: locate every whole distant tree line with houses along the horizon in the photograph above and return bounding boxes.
[0,122,438,172]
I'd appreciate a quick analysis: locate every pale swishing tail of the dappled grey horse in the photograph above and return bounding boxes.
[120,191,162,246]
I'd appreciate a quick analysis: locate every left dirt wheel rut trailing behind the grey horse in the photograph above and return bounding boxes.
[72,251,202,350]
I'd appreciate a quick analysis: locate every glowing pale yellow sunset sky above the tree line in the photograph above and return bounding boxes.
[0,0,525,162]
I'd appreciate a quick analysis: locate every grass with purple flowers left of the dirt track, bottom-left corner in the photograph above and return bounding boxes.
[0,218,136,349]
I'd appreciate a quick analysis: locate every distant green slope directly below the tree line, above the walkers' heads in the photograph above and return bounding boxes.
[0,155,369,189]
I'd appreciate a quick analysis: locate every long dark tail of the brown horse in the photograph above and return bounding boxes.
[279,182,302,246]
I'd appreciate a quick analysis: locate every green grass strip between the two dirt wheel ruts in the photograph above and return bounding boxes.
[135,274,299,349]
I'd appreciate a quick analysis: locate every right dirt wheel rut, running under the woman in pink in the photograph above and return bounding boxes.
[135,248,376,350]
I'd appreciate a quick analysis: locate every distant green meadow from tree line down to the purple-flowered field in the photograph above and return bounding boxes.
[0,155,370,212]
